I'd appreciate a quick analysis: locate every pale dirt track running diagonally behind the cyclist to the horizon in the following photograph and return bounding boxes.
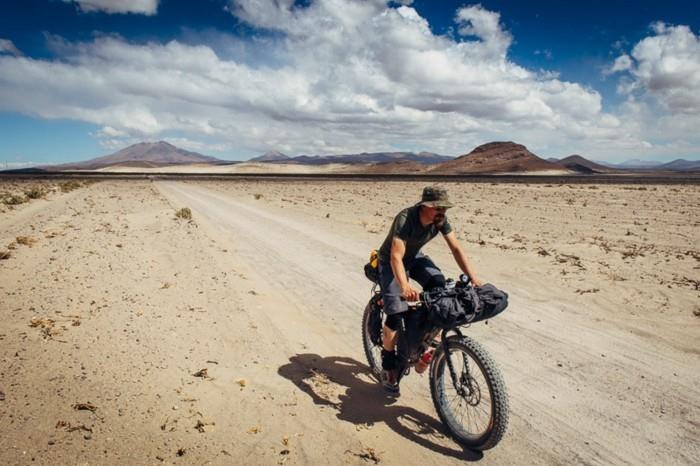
[156,184,700,463]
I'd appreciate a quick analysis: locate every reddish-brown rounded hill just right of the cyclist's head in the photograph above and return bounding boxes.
[429,141,567,174]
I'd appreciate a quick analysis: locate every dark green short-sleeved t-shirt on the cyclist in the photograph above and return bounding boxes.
[379,205,452,262]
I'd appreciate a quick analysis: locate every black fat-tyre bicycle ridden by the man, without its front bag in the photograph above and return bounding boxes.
[362,275,508,450]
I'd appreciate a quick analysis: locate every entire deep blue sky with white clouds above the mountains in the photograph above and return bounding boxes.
[0,0,700,166]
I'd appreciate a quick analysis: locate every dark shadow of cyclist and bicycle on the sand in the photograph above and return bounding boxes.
[277,354,483,461]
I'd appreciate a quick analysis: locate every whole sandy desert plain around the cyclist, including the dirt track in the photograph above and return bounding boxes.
[0,177,700,464]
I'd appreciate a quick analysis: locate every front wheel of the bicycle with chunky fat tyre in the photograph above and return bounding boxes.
[430,337,508,450]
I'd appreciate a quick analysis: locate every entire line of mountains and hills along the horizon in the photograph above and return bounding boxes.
[20,141,700,175]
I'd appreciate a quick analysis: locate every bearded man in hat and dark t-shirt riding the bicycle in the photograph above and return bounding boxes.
[378,186,482,396]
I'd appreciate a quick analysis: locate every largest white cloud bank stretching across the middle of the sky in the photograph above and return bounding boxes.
[0,0,688,160]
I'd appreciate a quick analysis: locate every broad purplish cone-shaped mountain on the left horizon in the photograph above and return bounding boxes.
[51,141,226,170]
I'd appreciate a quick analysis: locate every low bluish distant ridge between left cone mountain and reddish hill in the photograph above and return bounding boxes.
[250,152,452,165]
